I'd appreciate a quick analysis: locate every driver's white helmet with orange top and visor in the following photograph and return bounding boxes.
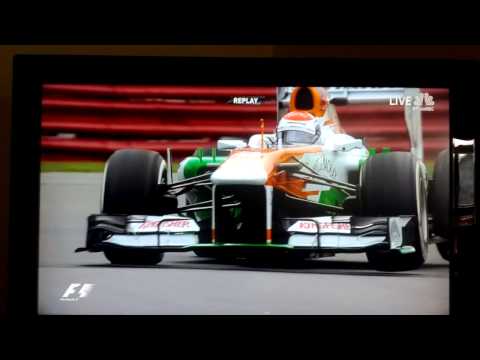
[277,111,321,147]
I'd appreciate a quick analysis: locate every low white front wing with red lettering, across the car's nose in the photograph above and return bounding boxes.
[76,214,416,253]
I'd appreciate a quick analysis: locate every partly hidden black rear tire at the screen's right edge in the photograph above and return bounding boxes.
[429,149,452,261]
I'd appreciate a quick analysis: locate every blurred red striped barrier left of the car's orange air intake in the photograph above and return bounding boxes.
[42,84,277,171]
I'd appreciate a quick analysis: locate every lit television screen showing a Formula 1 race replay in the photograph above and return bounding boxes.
[38,83,451,315]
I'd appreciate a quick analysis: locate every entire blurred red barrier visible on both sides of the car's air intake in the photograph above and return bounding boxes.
[42,84,449,171]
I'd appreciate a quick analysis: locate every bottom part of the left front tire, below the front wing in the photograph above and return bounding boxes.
[103,248,163,266]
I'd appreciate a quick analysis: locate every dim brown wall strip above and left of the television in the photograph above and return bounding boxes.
[0,45,480,317]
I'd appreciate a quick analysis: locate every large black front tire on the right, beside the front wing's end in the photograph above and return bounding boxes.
[360,152,428,271]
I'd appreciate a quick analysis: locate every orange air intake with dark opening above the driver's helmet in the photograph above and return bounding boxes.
[290,87,328,117]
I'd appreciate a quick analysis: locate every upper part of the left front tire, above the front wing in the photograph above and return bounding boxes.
[101,149,176,215]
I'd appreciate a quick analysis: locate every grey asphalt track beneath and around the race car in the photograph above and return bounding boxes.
[38,173,449,315]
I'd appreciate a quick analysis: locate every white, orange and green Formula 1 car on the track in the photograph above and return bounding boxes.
[77,88,448,271]
